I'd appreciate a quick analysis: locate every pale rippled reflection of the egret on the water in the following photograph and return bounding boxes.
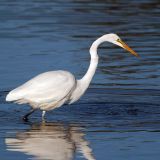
[5,123,95,160]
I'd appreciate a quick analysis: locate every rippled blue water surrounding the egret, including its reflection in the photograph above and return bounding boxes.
[0,0,160,160]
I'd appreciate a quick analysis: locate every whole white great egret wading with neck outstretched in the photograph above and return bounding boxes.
[6,33,138,120]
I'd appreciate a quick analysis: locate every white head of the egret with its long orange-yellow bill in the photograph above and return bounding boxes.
[103,33,138,57]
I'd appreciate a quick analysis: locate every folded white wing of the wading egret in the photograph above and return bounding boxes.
[6,71,76,103]
